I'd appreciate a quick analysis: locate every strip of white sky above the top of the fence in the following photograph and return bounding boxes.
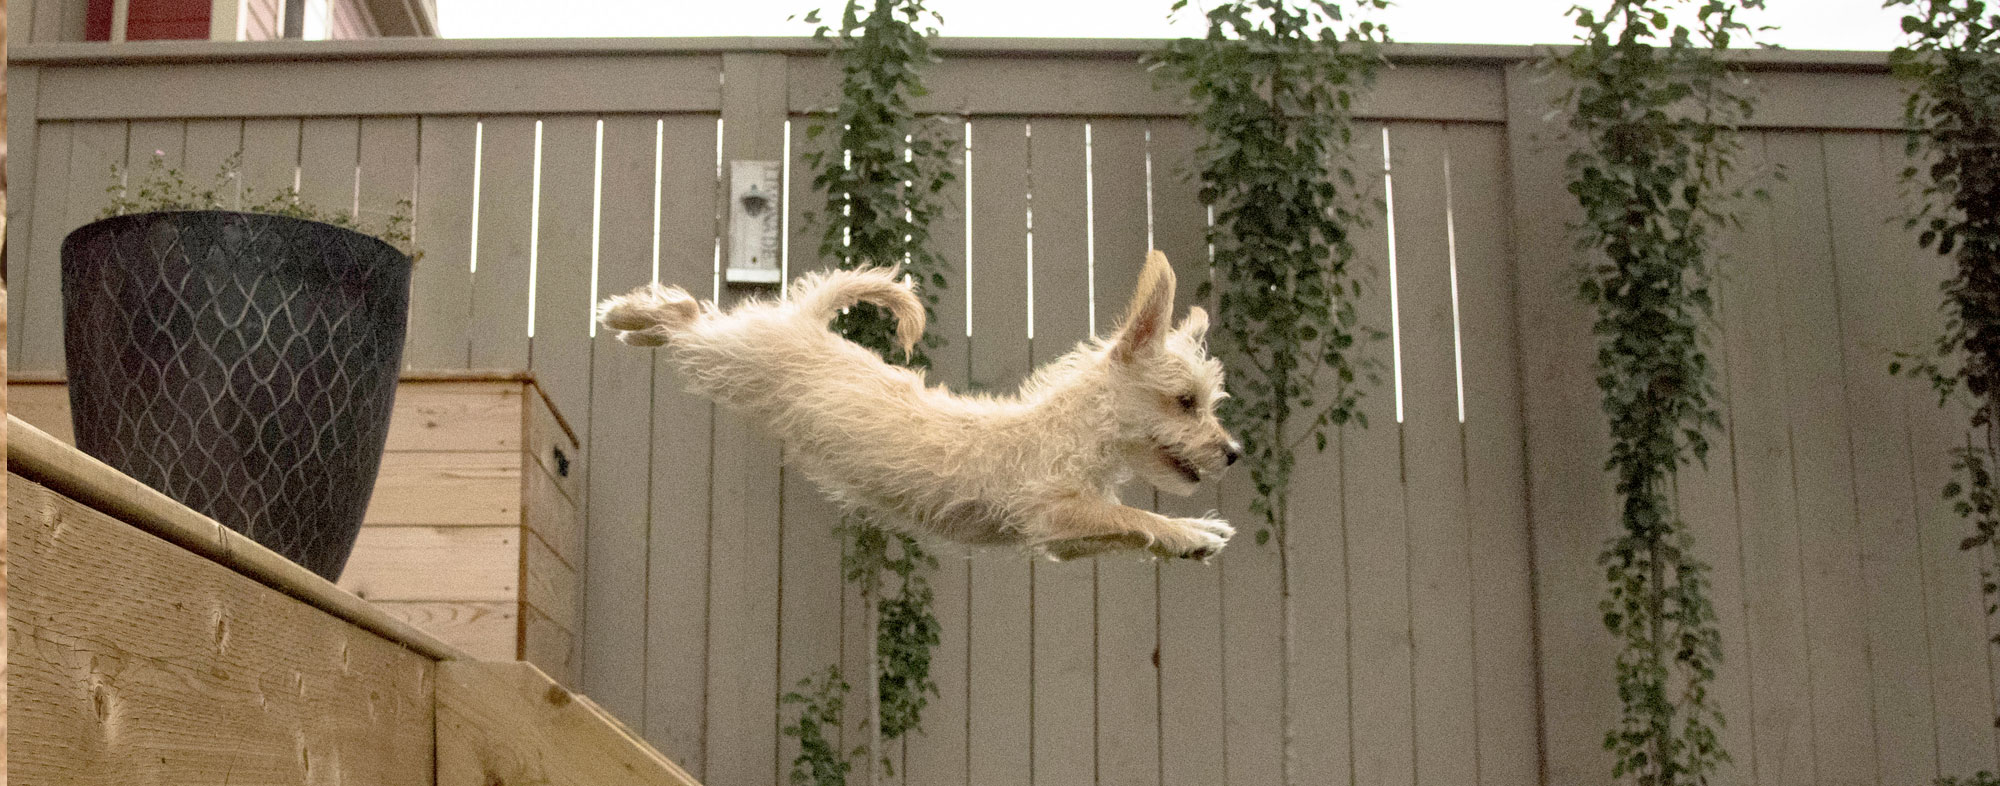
[438,0,1902,50]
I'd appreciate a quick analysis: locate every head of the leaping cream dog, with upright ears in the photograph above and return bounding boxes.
[1108,252,1242,496]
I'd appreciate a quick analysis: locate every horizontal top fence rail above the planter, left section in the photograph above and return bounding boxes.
[44,54,728,120]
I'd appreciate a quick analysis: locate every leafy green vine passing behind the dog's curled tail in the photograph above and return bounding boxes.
[784,0,956,786]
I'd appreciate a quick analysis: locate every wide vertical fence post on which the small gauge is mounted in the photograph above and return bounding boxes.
[702,54,788,782]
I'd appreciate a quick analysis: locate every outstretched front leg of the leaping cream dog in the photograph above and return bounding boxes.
[1034,498,1236,560]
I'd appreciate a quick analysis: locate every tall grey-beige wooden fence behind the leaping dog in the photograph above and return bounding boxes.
[8,32,2000,786]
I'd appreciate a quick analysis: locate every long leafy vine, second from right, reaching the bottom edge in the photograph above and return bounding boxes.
[1548,0,1762,786]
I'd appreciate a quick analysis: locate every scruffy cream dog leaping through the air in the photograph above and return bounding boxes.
[598,252,1240,560]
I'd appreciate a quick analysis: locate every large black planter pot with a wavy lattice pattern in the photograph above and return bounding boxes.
[62,210,410,580]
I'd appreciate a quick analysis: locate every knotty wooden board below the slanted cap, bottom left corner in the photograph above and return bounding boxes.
[8,474,432,784]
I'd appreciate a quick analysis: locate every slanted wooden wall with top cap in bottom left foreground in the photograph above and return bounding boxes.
[6,416,700,786]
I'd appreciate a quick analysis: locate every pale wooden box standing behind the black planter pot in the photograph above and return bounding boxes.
[8,372,582,688]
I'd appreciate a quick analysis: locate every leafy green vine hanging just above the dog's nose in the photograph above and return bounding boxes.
[1154,0,1388,544]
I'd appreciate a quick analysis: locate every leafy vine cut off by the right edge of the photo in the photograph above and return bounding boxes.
[1888,0,2000,764]
